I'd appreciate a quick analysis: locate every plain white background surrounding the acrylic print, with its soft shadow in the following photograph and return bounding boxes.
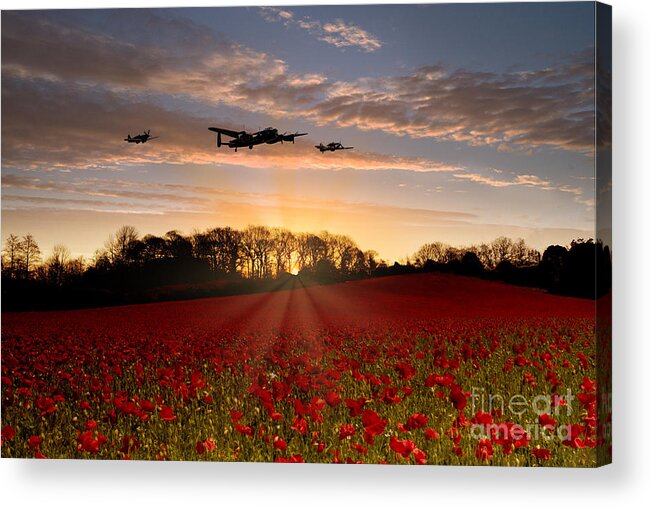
[0,0,651,507]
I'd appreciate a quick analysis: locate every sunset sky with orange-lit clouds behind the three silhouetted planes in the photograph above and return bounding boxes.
[1,2,595,261]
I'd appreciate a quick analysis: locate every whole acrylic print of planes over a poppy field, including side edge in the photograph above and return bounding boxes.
[2,2,612,467]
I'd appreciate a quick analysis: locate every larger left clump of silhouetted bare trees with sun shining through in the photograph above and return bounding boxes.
[2,225,385,310]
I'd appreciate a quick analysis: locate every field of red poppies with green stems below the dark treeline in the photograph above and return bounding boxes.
[2,274,610,467]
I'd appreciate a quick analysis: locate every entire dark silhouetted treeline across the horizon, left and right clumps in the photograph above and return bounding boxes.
[2,225,610,310]
